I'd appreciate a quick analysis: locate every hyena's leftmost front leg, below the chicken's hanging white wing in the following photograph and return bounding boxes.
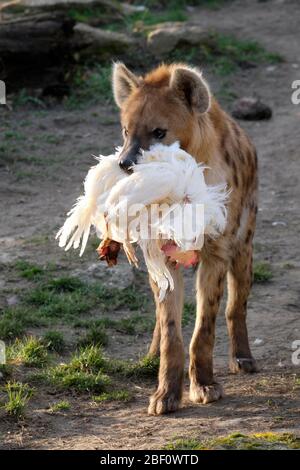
[148,266,184,415]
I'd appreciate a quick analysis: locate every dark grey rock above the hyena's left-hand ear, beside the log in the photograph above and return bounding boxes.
[73,23,135,54]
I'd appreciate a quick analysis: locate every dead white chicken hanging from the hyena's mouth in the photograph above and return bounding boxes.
[57,143,228,300]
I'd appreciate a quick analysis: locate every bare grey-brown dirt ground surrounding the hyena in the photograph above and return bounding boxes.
[0,0,300,449]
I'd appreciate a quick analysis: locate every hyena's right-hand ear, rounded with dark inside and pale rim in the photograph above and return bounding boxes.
[170,67,211,113]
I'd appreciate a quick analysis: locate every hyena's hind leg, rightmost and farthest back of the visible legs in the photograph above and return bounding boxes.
[226,241,258,372]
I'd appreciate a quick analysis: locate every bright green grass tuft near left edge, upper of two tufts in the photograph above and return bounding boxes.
[7,336,48,367]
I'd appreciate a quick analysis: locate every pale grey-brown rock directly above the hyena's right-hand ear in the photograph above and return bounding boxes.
[147,23,208,55]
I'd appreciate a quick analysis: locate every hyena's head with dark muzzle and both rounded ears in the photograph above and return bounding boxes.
[113,63,211,171]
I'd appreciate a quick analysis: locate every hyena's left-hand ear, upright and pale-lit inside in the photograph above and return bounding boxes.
[112,62,140,108]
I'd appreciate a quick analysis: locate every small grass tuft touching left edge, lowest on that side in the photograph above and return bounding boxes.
[3,382,33,419]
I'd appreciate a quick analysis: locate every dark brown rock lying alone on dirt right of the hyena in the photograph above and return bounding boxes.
[232,97,272,121]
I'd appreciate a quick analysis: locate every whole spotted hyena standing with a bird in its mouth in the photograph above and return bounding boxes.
[113,63,257,415]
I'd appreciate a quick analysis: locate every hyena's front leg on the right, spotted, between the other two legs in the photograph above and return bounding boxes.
[189,258,226,404]
